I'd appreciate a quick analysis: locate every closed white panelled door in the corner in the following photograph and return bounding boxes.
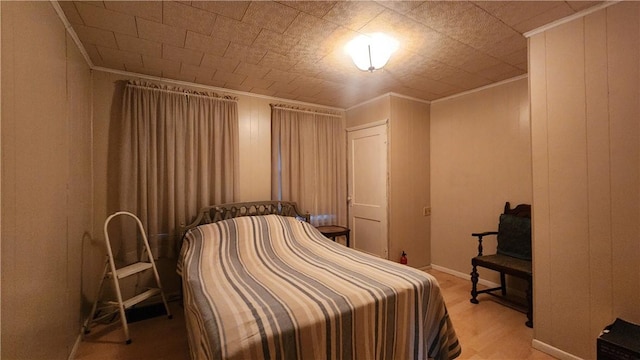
[347,121,388,259]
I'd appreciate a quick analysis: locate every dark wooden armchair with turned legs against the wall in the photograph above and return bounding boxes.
[470,202,533,327]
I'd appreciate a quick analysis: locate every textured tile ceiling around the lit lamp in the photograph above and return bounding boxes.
[59,1,600,108]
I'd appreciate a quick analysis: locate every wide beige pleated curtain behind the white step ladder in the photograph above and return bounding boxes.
[120,82,238,260]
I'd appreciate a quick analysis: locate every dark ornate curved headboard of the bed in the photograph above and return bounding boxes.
[180,201,311,239]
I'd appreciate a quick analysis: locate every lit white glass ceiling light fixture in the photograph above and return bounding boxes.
[345,33,398,72]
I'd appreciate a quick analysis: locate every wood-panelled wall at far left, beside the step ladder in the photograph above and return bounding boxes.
[0,2,92,359]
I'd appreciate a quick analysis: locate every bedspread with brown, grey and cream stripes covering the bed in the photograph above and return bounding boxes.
[178,215,461,360]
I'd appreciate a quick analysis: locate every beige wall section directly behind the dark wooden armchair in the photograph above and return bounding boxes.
[431,78,535,282]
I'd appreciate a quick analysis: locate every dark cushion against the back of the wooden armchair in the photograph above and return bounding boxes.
[498,214,531,260]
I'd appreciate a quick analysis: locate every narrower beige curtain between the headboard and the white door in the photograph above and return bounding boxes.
[271,105,347,226]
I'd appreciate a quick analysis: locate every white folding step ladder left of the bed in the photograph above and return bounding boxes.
[83,211,172,344]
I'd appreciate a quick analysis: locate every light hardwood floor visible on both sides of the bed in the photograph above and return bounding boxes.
[74,270,554,360]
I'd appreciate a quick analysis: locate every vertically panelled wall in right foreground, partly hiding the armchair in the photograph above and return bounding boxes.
[529,2,640,358]
